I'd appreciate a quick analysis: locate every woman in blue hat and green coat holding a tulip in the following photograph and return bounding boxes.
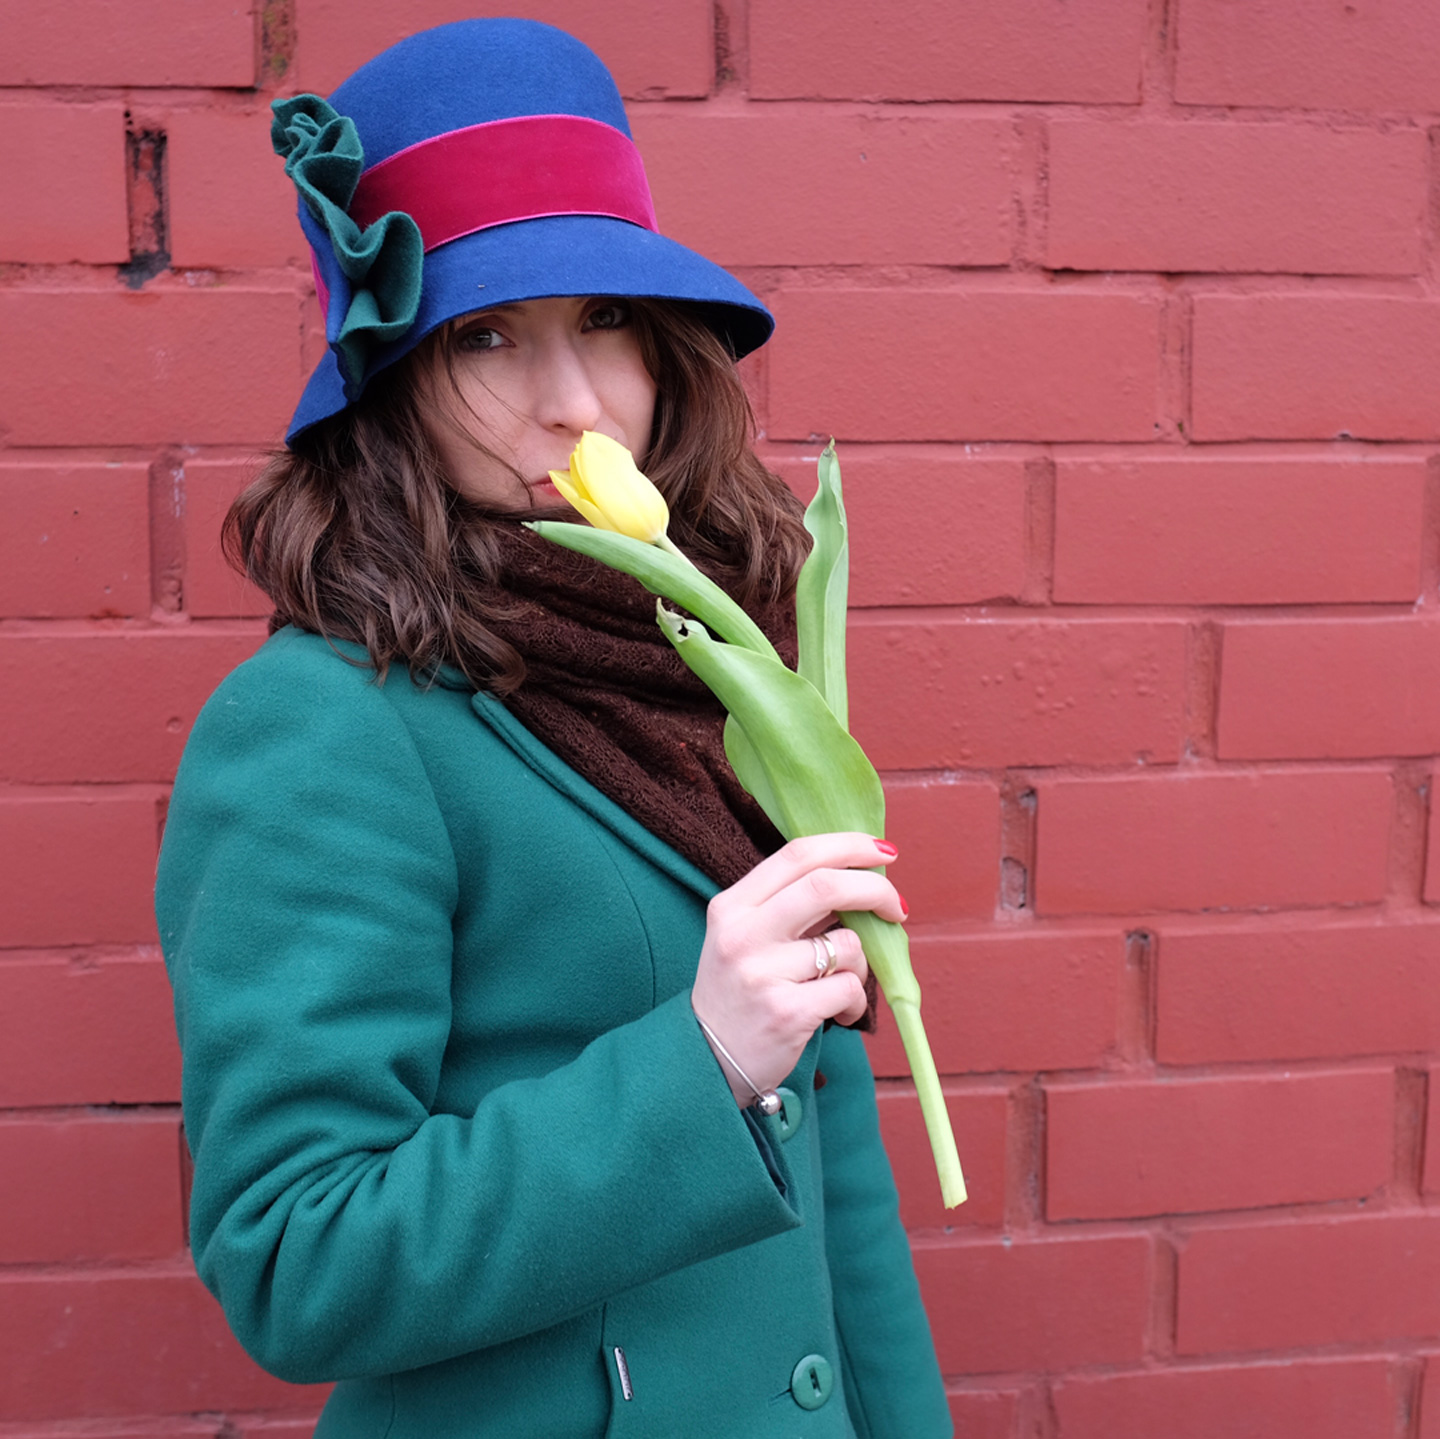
[157,20,950,1439]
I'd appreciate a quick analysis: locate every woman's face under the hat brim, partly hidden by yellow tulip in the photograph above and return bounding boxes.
[420,297,655,510]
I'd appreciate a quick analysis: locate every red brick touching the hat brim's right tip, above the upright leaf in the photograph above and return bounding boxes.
[766,288,1161,441]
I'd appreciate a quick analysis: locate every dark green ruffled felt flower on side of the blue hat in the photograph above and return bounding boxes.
[271,95,425,393]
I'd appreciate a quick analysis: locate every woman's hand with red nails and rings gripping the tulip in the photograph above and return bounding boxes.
[690,834,906,1106]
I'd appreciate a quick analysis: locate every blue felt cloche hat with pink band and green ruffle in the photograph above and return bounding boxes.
[271,20,775,444]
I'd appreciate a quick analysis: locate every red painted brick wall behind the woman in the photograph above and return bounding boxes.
[0,0,1440,1439]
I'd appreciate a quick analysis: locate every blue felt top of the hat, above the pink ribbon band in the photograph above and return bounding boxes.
[330,20,629,167]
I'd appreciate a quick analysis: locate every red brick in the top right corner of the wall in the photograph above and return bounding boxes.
[1175,0,1440,111]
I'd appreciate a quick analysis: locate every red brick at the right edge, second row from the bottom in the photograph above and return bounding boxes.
[1176,1211,1440,1354]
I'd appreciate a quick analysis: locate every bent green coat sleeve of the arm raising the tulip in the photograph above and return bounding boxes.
[157,651,799,1381]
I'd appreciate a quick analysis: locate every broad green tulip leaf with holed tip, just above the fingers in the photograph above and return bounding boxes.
[658,605,886,840]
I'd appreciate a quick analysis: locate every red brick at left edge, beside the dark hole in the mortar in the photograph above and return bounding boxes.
[0,102,130,265]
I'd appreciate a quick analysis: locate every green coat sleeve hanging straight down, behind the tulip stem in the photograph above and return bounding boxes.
[815,1027,953,1439]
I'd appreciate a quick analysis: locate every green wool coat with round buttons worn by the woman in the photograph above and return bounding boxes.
[157,629,950,1439]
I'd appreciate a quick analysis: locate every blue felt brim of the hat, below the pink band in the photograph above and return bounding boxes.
[285,215,775,445]
